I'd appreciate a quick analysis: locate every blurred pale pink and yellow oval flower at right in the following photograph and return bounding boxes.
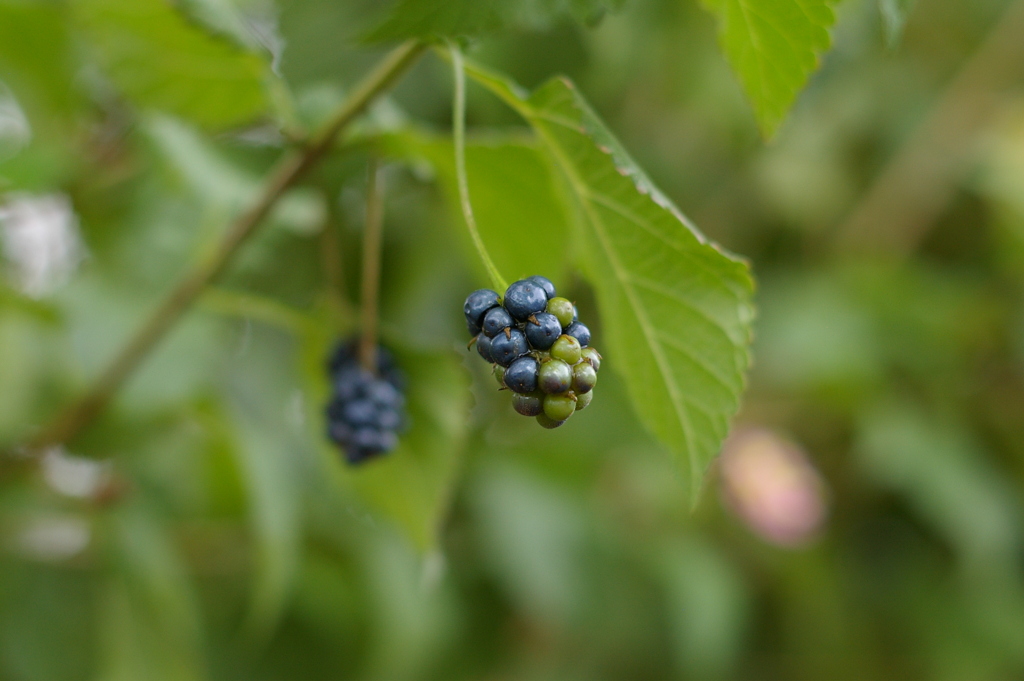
[719,428,827,547]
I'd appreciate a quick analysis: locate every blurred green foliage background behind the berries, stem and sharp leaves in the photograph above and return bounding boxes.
[0,0,1024,681]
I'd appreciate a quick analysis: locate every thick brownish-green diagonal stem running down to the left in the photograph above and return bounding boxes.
[19,41,425,454]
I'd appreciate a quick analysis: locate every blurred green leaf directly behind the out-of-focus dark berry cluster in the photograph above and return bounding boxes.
[303,324,469,554]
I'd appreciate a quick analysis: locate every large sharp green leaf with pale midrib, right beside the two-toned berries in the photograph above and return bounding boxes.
[469,67,754,498]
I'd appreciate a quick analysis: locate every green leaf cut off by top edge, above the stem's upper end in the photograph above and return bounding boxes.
[367,0,625,41]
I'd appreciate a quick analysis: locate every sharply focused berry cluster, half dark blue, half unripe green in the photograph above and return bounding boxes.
[463,276,601,428]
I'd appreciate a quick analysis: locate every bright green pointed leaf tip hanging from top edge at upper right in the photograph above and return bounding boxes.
[703,0,836,137]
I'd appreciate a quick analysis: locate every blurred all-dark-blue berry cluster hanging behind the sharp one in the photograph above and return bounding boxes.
[327,341,406,464]
